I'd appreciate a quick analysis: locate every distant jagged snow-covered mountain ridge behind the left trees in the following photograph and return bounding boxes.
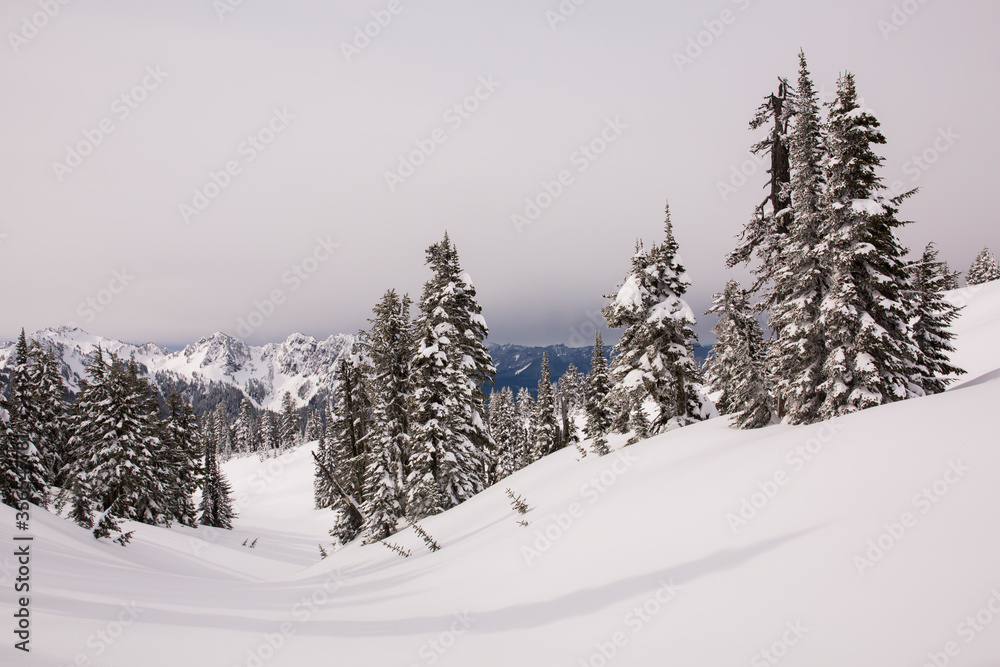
[0,327,354,409]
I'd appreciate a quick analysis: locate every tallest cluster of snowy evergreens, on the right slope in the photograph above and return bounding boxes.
[705,54,961,428]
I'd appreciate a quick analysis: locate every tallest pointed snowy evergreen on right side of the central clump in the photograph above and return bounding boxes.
[407,234,496,519]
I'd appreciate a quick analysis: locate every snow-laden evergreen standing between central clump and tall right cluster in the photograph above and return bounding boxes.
[603,201,704,431]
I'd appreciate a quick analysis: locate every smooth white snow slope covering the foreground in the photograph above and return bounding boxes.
[0,283,1000,667]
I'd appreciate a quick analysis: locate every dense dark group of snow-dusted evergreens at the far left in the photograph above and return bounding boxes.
[0,331,221,544]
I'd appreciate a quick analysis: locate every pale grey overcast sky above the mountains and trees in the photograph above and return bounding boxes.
[0,0,1000,345]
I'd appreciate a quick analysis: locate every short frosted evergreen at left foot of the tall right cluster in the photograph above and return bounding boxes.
[703,280,771,428]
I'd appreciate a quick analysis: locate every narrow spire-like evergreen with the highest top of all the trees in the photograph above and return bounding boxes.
[768,52,826,424]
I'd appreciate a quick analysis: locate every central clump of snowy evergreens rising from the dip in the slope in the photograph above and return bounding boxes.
[315,234,505,542]
